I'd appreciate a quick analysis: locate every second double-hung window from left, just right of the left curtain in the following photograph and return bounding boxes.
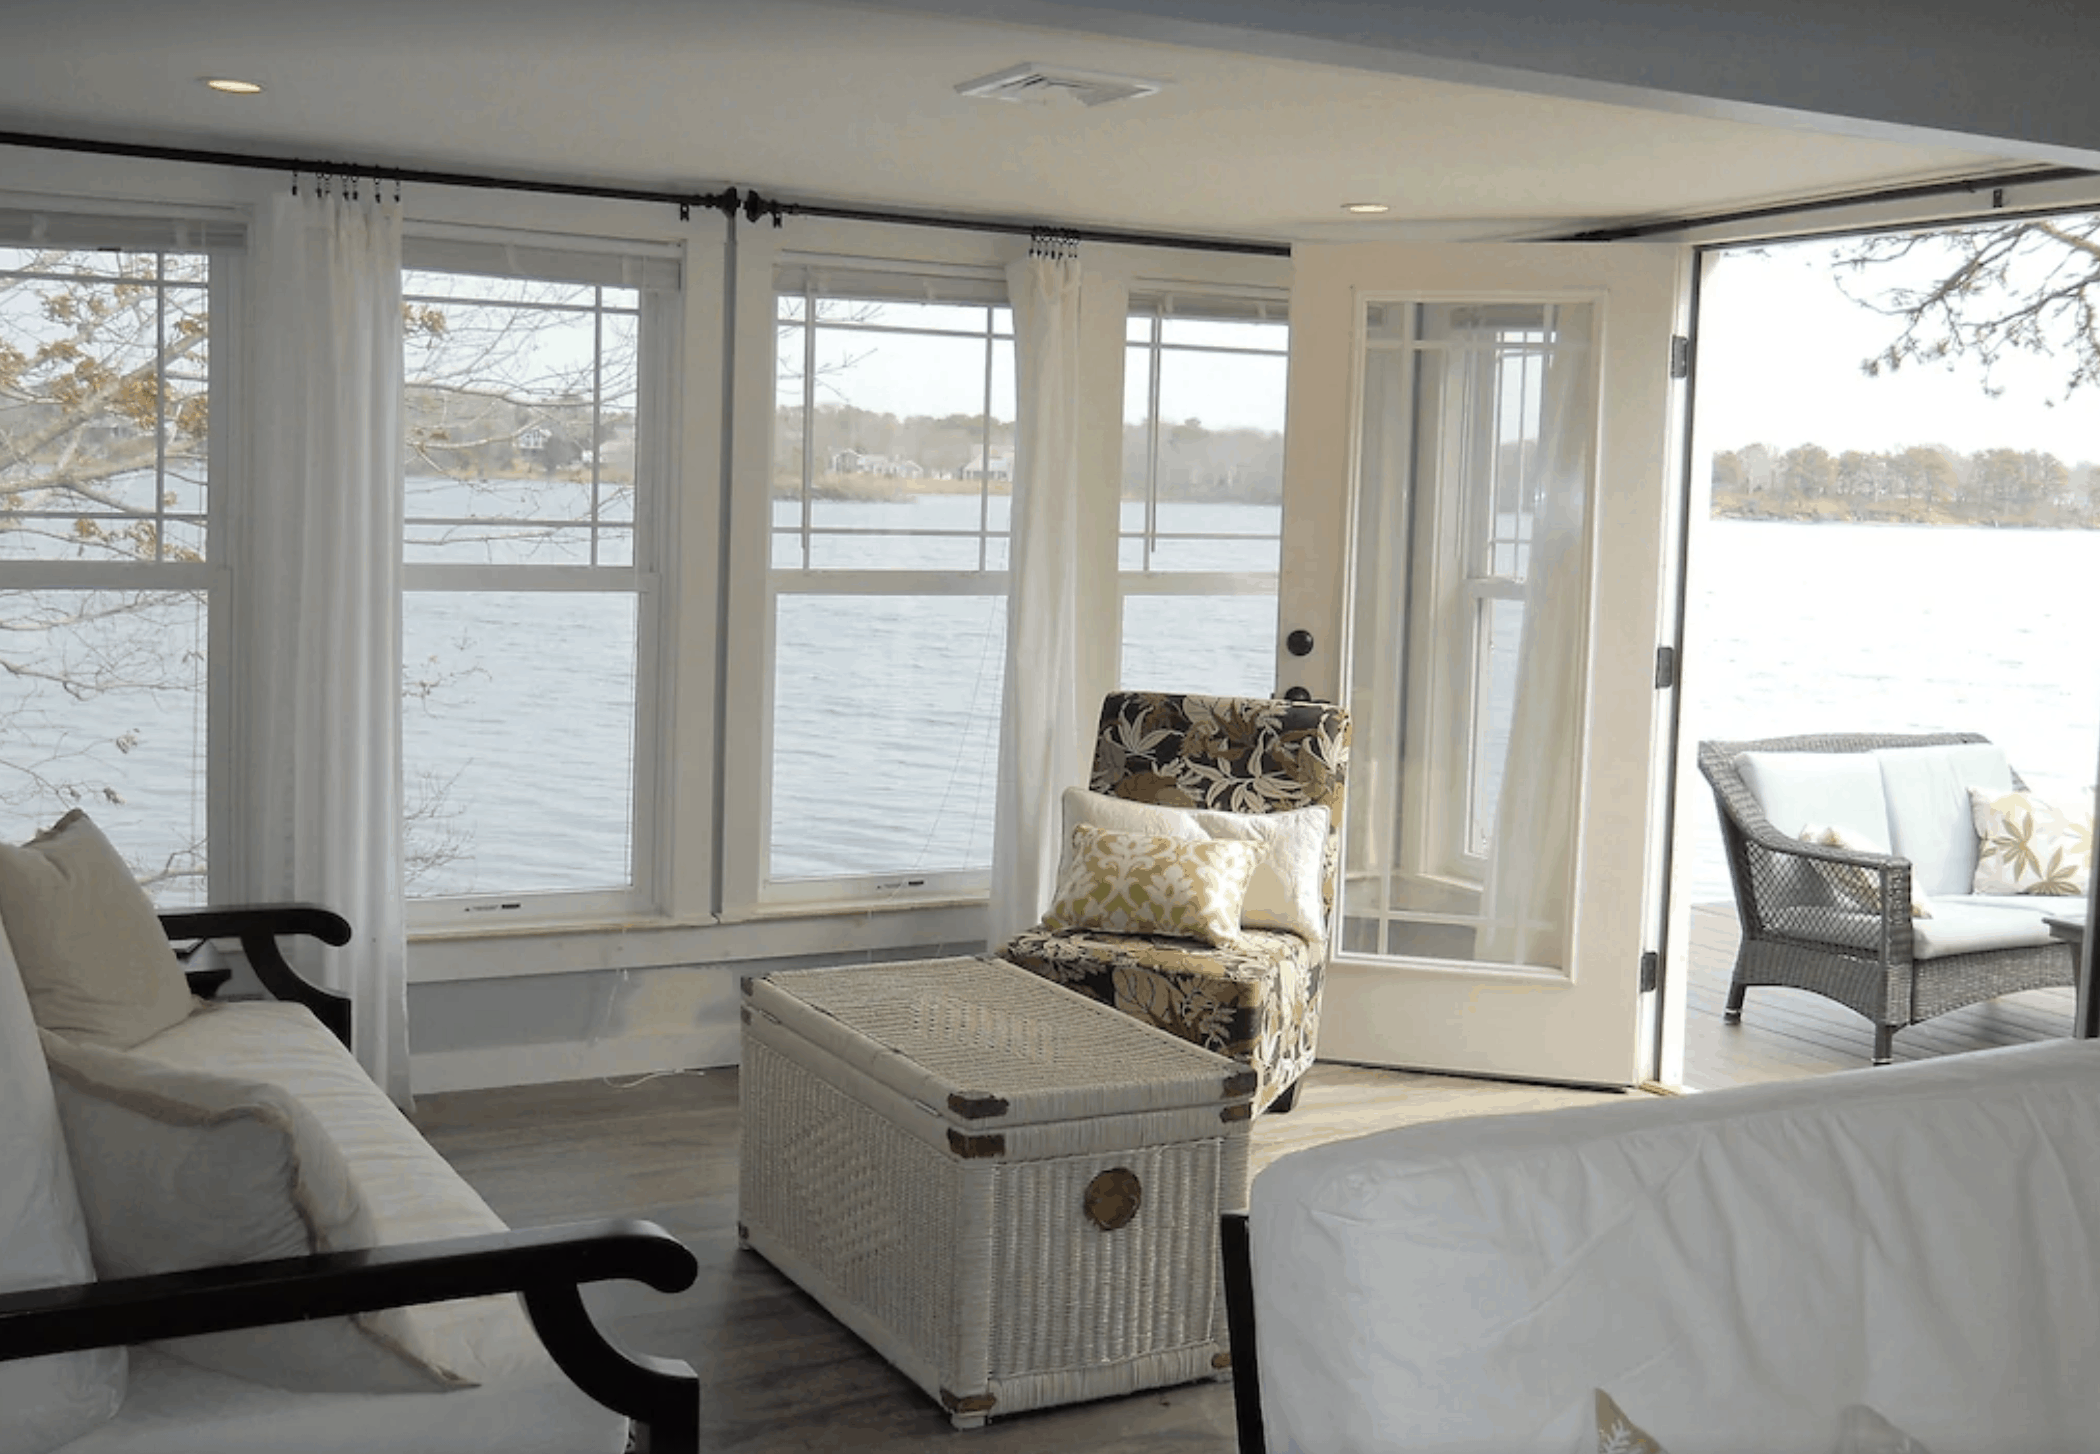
[401,237,678,925]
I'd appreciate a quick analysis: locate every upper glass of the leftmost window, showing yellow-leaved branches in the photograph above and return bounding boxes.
[0,248,210,561]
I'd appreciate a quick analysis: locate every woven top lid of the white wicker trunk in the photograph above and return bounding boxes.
[752,958,1252,1126]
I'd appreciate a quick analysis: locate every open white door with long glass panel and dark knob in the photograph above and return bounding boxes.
[1281,244,1688,1084]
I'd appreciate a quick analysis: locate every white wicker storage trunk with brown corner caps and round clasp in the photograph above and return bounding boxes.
[737,958,1254,1429]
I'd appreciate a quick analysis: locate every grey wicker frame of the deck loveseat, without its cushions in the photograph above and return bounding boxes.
[1699,731,2077,1065]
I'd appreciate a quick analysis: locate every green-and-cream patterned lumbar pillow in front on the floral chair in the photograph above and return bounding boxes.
[1044,824,1264,946]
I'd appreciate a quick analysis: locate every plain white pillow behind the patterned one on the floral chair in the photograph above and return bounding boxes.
[1065,788,1327,943]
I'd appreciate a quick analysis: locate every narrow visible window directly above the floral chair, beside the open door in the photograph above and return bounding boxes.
[1117,292,1289,698]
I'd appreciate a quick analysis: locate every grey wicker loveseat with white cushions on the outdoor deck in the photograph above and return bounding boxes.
[1699,733,2083,1065]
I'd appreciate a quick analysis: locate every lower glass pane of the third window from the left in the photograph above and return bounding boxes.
[769,595,1006,880]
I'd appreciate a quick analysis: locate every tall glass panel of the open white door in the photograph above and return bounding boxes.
[1342,303,1596,969]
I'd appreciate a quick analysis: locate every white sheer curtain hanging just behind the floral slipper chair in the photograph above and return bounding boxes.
[987,242,1090,950]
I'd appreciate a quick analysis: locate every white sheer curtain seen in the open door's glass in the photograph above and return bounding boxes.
[1474,305,1596,967]
